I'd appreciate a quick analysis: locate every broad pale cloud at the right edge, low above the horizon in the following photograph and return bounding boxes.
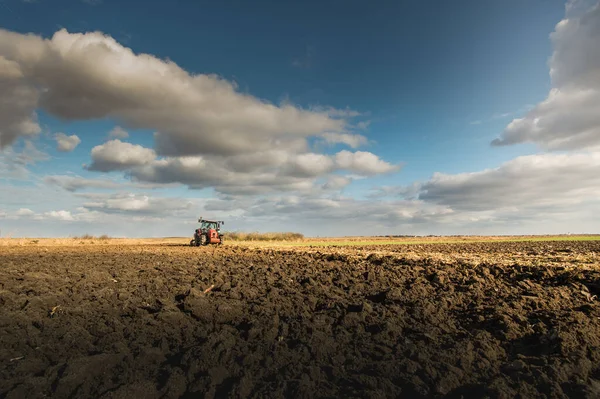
[419,153,600,211]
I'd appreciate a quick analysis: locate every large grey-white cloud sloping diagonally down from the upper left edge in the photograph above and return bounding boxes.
[0,29,364,156]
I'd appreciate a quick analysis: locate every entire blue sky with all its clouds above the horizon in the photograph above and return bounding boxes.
[0,0,600,235]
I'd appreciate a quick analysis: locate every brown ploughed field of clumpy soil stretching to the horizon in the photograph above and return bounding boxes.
[0,239,600,399]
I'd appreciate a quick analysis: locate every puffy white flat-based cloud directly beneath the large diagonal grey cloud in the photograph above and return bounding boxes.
[120,151,398,195]
